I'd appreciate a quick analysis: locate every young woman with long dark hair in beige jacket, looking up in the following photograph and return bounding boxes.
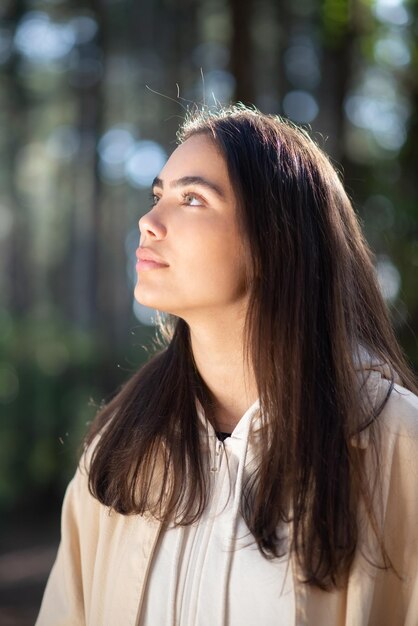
[37,106,418,626]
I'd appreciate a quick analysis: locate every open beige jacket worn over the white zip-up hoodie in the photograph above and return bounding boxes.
[36,364,418,626]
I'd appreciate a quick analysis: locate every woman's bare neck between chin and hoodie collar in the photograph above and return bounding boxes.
[190,316,258,433]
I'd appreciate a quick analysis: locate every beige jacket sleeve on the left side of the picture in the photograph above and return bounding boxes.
[36,456,100,626]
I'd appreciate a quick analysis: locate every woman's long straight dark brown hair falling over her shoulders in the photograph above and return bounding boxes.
[87,106,416,588]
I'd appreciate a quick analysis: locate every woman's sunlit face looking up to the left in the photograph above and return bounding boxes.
[135,134,249,321]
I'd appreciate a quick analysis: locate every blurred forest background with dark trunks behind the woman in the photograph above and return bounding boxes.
[0,0,418,626]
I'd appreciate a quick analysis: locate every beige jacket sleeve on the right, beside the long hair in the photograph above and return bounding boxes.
[345,385,418,626]
